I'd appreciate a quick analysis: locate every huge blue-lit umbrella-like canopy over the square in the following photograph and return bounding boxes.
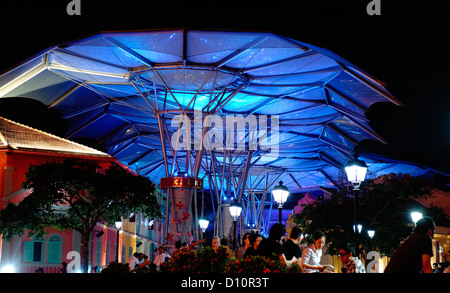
[0,29,432,192]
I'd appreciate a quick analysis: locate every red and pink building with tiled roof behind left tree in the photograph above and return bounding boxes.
[0,118,157,273]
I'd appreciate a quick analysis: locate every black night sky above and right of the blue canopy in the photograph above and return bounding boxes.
[0,0,450,174]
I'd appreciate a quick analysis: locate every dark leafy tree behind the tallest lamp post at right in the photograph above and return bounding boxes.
[294,174,445,256]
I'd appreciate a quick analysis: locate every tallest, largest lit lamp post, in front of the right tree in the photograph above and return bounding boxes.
[345,155,367,256]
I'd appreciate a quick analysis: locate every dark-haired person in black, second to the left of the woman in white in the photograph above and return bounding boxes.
[257,223,286,266]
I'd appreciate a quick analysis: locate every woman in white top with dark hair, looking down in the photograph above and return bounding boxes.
[301,231,329,273]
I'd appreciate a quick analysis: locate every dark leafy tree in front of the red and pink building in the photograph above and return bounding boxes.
[0,159,161,272]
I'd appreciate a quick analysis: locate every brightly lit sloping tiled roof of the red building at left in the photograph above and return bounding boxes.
[0,117,112,158]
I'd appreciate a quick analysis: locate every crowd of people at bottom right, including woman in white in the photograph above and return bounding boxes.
[241,217,450,273]
